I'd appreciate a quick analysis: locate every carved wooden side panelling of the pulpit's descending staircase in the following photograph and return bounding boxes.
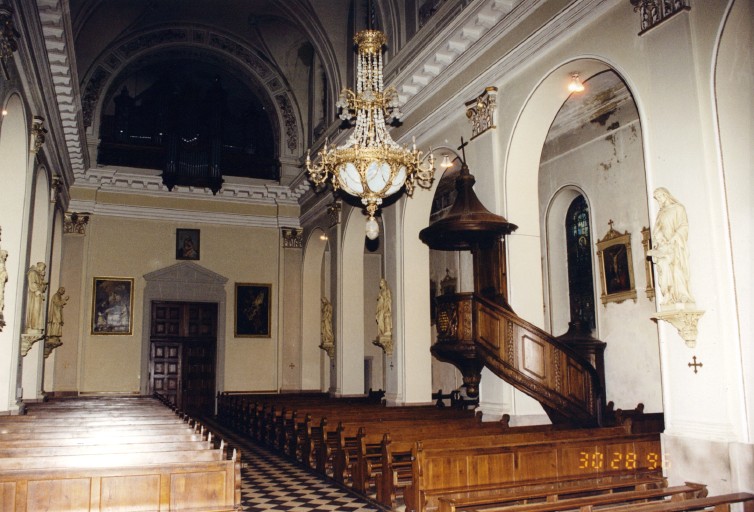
[473,295,603,426]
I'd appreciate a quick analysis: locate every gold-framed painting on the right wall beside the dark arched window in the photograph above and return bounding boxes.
[597,220,636,305]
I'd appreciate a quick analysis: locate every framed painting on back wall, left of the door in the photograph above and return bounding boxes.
[92,277,134,335]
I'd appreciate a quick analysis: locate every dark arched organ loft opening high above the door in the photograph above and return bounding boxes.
[97,48,280,188]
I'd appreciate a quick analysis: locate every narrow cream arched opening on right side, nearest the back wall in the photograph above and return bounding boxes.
[301,227,330,391]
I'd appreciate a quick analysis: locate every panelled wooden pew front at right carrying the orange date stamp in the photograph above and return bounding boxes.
[400,429,661,511]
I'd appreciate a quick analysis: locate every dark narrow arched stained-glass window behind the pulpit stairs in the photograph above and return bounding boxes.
[565,195,595,330]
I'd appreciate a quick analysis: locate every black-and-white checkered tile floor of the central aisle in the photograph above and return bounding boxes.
[206,422,384,512]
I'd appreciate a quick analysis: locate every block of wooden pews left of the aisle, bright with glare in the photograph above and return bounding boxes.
[0,397,240,512]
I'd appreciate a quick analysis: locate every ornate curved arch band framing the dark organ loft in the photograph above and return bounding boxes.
[81,25,304,158]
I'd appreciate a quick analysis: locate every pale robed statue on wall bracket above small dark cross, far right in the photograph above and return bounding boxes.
[648,187,694,306]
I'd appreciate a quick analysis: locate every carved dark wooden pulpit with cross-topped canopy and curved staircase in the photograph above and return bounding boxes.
[419,159,605,426]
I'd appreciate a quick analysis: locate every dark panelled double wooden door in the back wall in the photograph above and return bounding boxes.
[149,301,217,417]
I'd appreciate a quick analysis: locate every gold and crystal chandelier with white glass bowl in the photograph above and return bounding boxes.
[306,29,435,240]
